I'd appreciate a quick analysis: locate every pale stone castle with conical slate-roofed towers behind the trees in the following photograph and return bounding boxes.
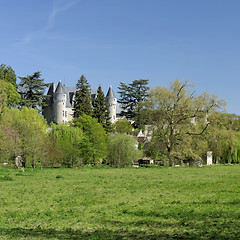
[43,81,117,124]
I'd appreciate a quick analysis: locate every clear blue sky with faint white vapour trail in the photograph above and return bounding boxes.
[0,0,240,115]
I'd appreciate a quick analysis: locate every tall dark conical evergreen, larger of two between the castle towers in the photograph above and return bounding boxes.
[73,75,92,118]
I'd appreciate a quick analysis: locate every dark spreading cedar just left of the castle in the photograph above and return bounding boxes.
[18,72,48,111]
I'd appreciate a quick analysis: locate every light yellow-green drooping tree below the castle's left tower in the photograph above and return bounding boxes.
[50,124,83,167]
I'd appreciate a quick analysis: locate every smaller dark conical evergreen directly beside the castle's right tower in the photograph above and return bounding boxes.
[93,86,111,132]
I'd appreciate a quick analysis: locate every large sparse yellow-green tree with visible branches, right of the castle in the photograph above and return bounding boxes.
[141,80,224,164]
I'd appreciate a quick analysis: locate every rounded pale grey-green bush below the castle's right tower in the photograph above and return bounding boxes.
[107,133,141,168]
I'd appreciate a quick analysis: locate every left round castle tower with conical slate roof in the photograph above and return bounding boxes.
[53,80,66,123]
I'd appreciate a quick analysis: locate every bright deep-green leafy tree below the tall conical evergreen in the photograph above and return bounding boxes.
[73,114,107,164]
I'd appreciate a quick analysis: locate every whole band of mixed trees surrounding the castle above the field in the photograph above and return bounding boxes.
[0,64,240,167]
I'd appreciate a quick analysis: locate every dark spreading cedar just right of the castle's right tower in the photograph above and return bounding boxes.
[118,79,149,127]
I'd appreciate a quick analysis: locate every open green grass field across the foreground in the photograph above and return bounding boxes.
[0,165,240,239]
